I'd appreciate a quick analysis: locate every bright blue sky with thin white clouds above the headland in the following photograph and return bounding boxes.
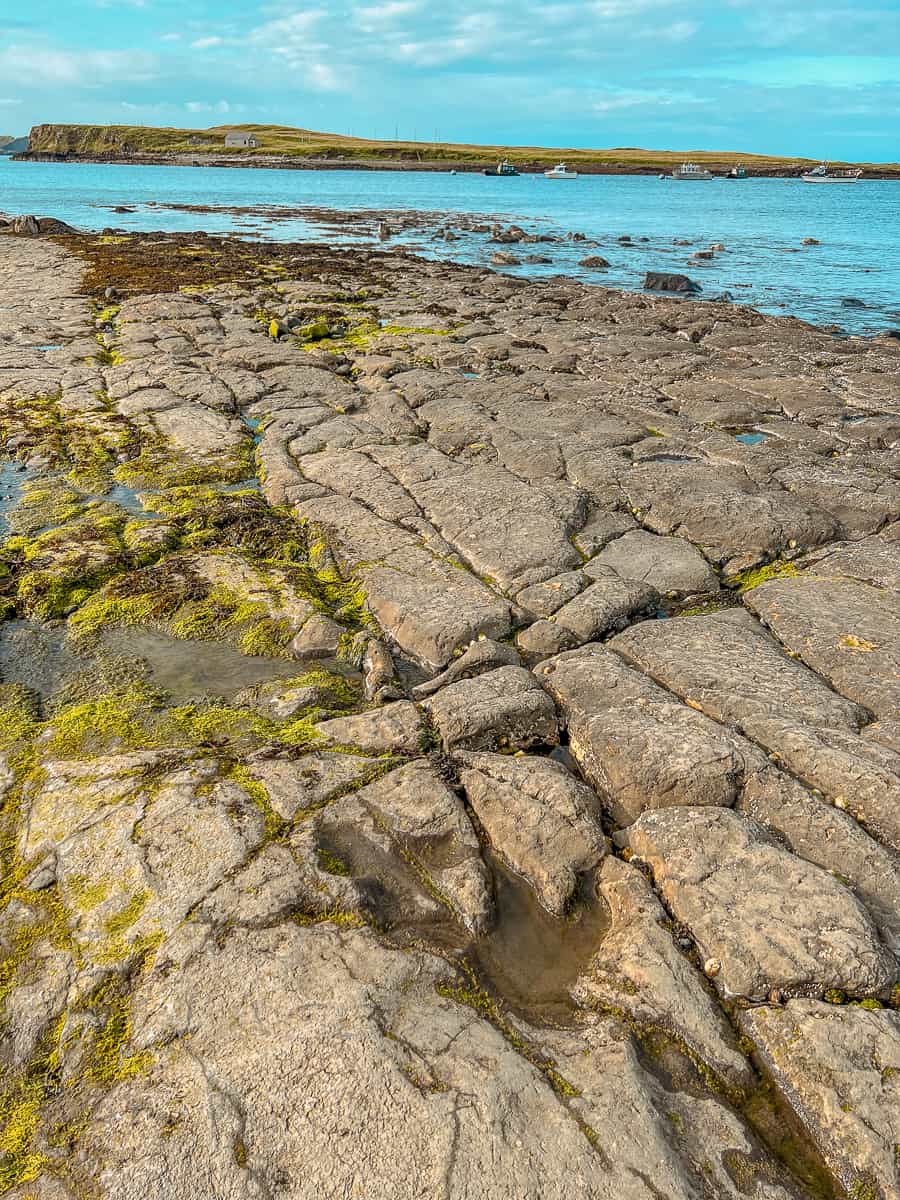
[0,0,900,161]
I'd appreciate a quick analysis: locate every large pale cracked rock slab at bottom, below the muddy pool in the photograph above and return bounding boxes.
[42,924,792,1200]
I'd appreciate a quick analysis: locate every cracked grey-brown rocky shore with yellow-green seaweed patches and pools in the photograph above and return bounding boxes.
[0,222,900,1200]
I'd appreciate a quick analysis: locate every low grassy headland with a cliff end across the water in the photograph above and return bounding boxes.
[23,125,900,178]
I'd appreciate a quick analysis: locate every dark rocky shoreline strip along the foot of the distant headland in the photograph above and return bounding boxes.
[12,151,900,182]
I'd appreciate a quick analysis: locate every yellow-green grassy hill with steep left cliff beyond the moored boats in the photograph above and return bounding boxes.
[22,125,900,173]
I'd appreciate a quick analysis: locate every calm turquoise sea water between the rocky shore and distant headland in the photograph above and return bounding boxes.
[0,157,900,332]
